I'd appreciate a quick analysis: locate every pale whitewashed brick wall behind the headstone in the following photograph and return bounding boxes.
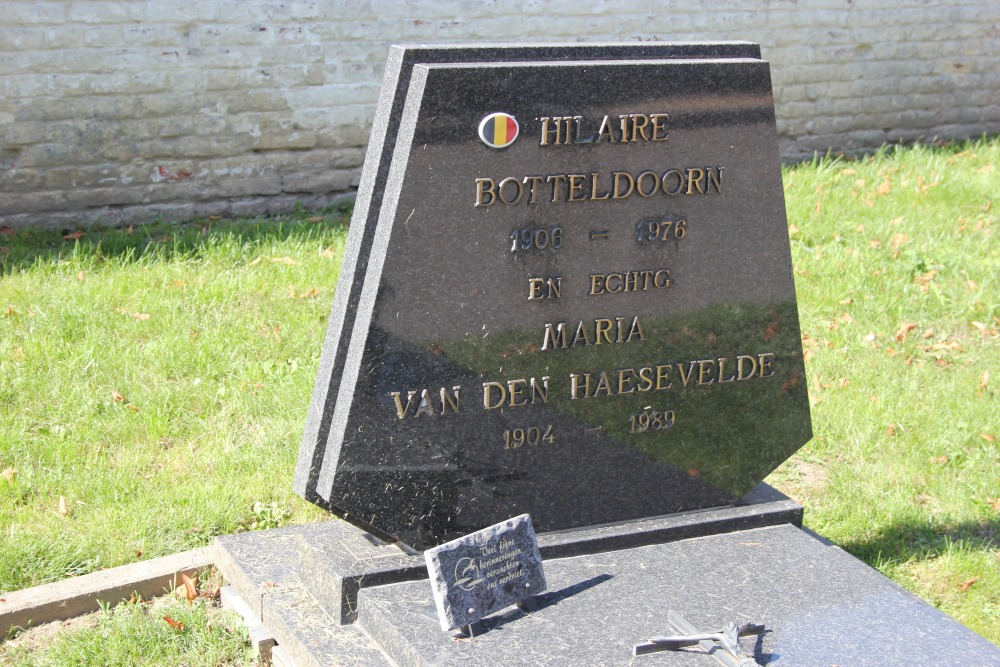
[0,0,1000,226]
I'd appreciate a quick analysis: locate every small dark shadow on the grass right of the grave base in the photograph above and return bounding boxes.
[838,518,1000,566]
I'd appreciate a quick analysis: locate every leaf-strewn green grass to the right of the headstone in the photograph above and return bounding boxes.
[769,139,1000,643]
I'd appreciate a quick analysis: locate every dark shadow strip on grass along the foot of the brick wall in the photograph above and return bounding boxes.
[0,206,351,276]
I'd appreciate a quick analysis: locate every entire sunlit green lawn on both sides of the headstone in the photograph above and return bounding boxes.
[0,140,1000,658]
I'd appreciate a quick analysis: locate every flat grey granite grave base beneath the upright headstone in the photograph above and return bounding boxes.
[217,485,1000,667]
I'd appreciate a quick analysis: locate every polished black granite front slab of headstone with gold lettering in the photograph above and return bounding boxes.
[297,45,810,548]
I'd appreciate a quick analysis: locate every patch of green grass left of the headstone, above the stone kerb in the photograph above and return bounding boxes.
[0,213,346,591]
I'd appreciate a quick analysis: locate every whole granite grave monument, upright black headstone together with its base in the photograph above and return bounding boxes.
[216,43,1000,667]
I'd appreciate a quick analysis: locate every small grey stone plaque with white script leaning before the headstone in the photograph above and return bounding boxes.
[424,514,545,630]
